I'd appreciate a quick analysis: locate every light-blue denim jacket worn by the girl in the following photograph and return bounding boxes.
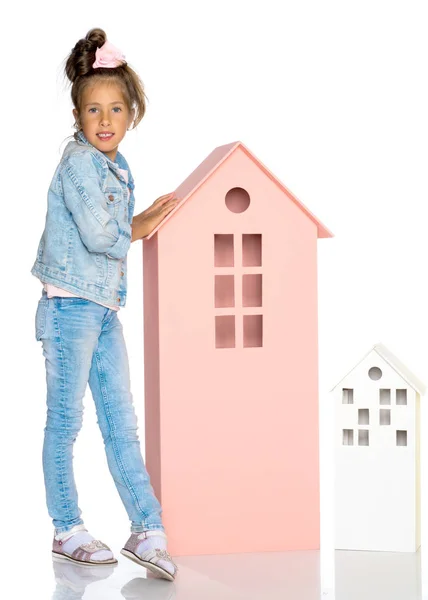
[31,131,135,306]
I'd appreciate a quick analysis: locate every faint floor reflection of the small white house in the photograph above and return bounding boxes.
[335,550,422,600]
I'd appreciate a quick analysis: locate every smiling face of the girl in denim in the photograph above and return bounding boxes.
[73,81,134,161]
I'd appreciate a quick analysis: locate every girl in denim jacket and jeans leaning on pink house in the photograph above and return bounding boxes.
[31,29,178,580]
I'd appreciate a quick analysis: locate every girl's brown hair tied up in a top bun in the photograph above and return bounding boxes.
[64,28,146,137]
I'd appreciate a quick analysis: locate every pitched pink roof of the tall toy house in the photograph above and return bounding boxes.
[144,141,333,240]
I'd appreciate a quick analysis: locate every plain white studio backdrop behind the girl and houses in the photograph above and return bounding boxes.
[0,0,428,587]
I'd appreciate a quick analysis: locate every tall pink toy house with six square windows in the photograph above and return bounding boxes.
[143,141,332,556]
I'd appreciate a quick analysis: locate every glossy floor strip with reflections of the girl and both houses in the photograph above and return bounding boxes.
[51,550,427,600]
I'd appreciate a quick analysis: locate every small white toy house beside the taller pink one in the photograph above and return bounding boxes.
[331,344,425,552]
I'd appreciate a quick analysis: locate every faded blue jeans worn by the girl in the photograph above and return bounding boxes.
[35,290,164,534]
